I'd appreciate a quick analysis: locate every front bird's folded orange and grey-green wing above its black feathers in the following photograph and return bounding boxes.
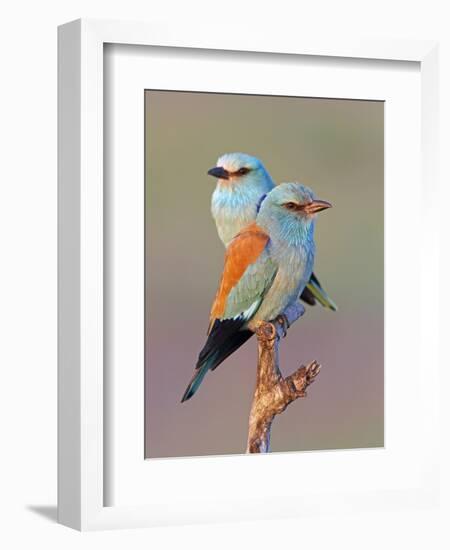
[209,223,276,332]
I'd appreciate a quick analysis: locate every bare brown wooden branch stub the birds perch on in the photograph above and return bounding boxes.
[247,303,320,453]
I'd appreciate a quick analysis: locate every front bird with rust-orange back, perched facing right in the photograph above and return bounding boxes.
[181,183,331,402]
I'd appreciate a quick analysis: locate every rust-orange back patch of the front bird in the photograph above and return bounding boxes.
[208,222,269,332]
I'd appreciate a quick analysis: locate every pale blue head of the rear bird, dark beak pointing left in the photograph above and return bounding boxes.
[208,153,274,192]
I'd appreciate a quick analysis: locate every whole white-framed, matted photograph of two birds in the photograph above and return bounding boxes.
[58,20,438,530]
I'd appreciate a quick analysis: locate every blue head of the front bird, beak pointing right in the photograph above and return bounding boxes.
[256,183,331,245]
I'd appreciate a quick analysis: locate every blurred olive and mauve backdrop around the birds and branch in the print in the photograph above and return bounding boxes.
[145,91,384,458]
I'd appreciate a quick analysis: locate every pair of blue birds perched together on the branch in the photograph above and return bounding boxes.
[181,153,336,402]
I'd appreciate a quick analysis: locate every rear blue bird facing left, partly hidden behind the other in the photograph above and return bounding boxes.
[208,153,337,311]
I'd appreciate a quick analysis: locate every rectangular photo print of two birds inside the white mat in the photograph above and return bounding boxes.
[144,90,384,459]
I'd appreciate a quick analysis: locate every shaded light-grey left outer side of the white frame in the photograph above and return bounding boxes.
[58,20,81,530]
